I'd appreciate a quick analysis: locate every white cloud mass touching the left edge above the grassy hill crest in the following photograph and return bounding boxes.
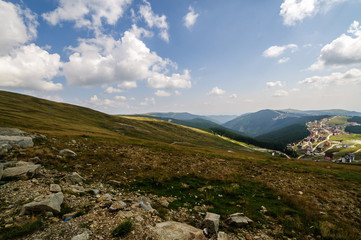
[0,0,63,91]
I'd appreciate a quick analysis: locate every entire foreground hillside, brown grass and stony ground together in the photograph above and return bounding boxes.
[0,91,361,240]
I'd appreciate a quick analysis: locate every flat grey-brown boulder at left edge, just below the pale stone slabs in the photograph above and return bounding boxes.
[3,162,41,179]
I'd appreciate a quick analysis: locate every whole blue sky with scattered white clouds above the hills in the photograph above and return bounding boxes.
[0,0,361,114]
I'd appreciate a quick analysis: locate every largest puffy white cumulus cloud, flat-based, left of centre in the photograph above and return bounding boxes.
[63,28,191,89]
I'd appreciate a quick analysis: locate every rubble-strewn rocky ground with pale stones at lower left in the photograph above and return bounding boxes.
[0,129,287,240]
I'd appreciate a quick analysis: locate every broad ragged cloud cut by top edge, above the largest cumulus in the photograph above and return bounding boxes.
[42,0,132,29]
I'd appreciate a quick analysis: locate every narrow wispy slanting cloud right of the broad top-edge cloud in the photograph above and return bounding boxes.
[139,0,169,42]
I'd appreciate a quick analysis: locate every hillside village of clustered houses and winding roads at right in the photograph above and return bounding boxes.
[287,117,361,163]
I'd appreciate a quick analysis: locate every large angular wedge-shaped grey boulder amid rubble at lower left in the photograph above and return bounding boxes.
[22,192,64,214]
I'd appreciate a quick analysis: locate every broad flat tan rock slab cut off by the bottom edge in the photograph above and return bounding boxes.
[152,221,206,240]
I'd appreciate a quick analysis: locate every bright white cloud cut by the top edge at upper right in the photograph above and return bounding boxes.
[280,0,347,26]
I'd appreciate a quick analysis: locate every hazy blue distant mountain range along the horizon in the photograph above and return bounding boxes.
[147,109,361,139]
